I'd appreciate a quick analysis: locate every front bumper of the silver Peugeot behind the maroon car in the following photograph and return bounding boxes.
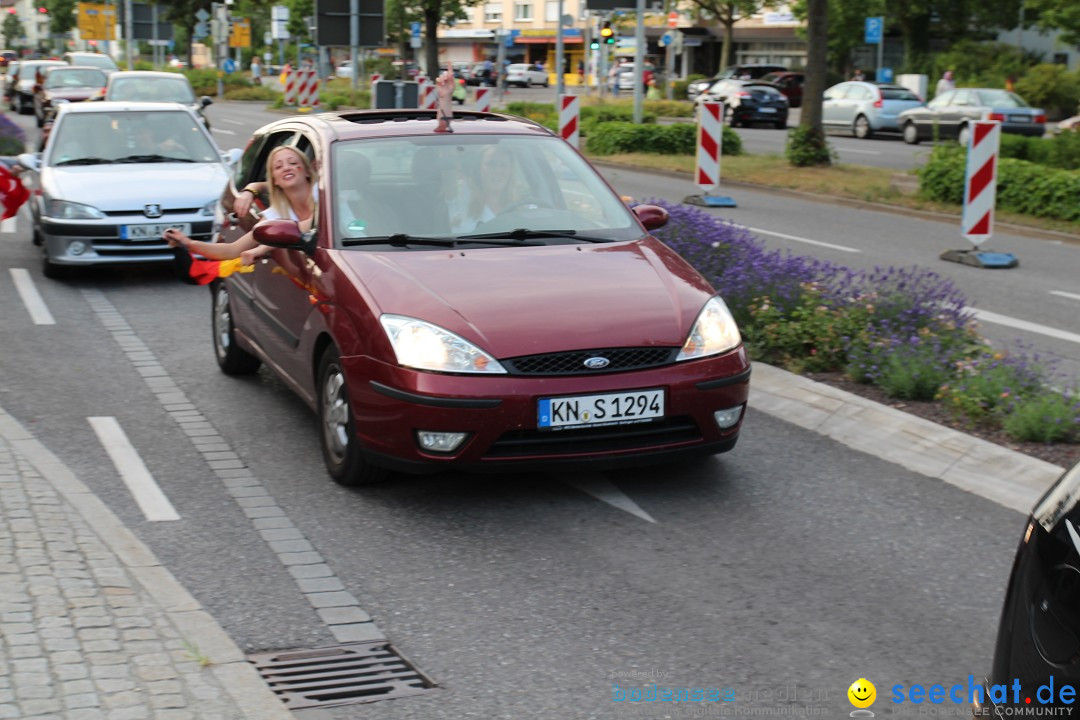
[35,214,213,266]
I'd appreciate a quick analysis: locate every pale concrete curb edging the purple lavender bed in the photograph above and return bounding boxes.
[750,363,1065,515]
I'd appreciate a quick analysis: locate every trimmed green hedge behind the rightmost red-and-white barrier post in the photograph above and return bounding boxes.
[919,144,1080,220]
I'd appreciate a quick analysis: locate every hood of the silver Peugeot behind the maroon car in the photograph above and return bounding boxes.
[41,163,228,212]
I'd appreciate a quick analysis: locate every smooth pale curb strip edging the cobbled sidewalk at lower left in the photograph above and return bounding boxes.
[0,408,294,720]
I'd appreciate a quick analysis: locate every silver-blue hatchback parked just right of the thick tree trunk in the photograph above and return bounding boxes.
[822,81,926,138]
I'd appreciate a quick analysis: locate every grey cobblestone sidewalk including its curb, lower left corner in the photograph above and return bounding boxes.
[0,409,293,720]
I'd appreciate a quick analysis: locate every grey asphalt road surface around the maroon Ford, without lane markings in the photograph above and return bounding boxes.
[0,98,1062,720]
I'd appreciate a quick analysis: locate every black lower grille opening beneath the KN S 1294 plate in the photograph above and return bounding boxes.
[485,417,701,459]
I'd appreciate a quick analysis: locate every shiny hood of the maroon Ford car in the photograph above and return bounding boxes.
[332,239,713,357]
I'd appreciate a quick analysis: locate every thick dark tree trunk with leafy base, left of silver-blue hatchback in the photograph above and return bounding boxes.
[787,0,832,165]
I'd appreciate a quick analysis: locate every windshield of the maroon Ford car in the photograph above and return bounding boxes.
[328,136,642,249]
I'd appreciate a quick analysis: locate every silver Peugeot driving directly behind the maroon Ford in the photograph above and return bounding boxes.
[18,103,241,277]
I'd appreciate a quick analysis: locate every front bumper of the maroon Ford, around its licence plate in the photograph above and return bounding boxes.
[342,347,750,472]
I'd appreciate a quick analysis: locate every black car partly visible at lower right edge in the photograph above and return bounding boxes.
[969,463,1080,718]
